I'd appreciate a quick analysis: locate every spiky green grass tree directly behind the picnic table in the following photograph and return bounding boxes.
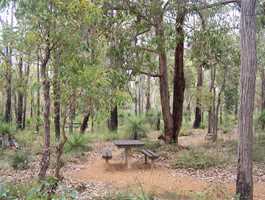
[127,115,146,139]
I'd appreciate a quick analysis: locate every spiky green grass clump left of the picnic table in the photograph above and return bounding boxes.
[64,133,91,153]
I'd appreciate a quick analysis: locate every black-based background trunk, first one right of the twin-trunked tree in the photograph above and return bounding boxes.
[193,65,203,129]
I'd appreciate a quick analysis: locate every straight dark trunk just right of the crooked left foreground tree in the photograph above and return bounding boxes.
[53,50,61,141]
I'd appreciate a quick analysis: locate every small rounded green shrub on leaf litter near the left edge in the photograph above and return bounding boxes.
[11,152,29,169]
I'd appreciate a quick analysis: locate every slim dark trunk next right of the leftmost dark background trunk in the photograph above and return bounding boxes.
[16,57,24,129]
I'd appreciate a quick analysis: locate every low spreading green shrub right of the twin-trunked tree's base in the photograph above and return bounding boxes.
[174,150,224,169]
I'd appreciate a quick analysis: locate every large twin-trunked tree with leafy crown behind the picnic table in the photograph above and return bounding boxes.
[102,0,236,143]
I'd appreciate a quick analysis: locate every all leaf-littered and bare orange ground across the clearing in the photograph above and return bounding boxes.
[0,130,265,200]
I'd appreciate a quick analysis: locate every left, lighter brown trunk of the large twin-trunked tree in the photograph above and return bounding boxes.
[155,16,174,142]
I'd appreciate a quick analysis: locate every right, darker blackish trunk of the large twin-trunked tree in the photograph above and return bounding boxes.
[170,13,185,144]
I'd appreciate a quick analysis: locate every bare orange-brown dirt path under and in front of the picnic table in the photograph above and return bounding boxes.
[65,131,265,200]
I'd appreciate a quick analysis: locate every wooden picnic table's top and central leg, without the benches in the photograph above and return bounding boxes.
[113,140,144,166]
